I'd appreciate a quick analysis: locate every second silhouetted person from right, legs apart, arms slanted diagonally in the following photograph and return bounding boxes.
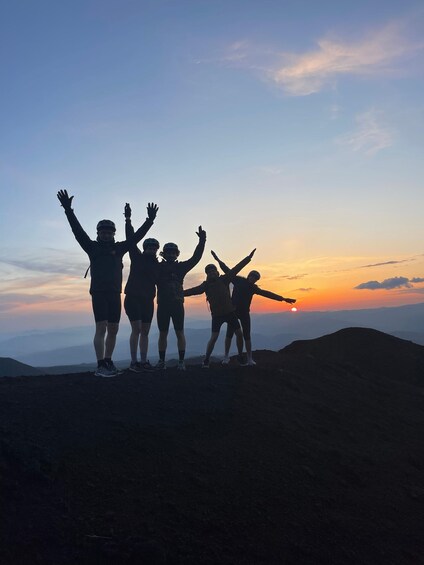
[184,249,256,369]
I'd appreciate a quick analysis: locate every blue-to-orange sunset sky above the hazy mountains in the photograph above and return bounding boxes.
[0,0,424,333]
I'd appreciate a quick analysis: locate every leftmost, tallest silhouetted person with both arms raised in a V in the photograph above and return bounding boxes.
[57,190,158,377]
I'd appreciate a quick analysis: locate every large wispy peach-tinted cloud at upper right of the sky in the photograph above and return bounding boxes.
[220,22,424,96]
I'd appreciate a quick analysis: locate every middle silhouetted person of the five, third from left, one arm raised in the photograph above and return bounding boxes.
[156,226,206,371]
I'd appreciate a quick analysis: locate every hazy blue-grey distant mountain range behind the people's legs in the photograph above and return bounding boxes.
[0,303,424,367]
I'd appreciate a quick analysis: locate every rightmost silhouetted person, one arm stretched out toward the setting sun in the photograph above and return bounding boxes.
[211,251,296,365]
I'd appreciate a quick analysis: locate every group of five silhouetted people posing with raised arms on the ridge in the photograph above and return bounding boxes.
[57,190,296,377]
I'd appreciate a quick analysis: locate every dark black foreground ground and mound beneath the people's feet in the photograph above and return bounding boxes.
[0,329,424,565]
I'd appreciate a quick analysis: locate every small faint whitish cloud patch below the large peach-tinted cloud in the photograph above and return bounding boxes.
[337,109,395,155]
